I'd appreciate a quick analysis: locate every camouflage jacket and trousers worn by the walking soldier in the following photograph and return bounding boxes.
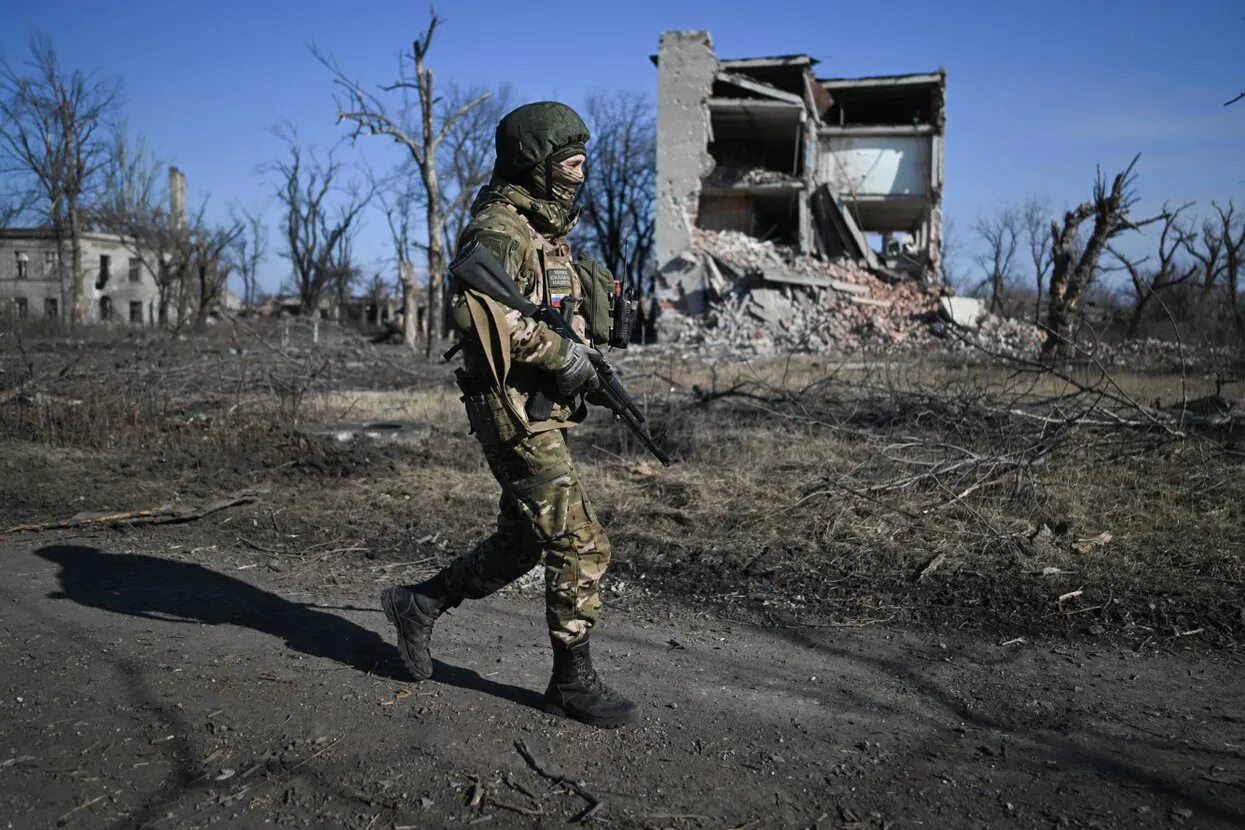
[446,120,610,646]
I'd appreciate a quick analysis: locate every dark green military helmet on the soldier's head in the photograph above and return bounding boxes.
[493,101,589,182]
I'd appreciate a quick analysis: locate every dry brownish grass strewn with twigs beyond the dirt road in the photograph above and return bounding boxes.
[0,326,1245,643]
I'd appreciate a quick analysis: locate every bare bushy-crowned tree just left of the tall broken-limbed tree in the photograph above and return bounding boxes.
[265,126,372,314]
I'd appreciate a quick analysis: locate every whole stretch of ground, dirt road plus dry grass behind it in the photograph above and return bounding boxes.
[0,323,1245,830]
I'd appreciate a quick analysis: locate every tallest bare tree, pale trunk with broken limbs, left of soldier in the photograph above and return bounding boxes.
[316,9,488,355]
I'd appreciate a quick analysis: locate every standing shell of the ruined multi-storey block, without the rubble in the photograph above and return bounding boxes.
[654,31,946,314]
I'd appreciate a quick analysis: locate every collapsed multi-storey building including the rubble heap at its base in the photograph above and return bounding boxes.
[637,31,1037,353]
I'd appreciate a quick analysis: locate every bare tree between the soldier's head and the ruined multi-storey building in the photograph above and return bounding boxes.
[581,91,657,294]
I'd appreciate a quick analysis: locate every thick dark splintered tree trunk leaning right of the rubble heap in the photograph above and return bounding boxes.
[1042,156,1163,362]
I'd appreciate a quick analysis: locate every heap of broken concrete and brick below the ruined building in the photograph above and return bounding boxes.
[662,229,1042,356]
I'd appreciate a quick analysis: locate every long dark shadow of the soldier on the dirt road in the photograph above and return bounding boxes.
[35,545,542,707]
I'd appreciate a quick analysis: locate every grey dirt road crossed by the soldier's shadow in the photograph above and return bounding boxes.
[0,531,1245,830]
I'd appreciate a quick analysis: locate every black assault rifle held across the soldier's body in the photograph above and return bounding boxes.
[449,239,671,467]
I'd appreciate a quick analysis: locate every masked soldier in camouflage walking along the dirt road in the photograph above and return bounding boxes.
[381,101,639,727]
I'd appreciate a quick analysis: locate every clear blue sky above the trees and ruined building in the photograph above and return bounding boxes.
[0,0,1245,287]
